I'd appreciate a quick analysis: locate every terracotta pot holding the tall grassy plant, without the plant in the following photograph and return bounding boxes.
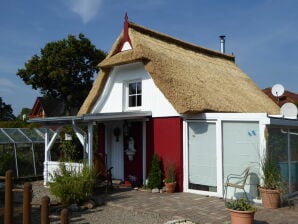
[259,188,280,208]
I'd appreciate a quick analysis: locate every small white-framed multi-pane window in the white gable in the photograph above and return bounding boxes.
[126,81,142,109]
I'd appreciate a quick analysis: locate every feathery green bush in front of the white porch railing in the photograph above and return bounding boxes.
[49,163,95,205]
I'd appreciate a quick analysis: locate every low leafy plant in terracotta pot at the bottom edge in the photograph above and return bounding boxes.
[226,198,256,224]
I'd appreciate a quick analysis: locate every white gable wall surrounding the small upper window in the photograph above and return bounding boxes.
[91,63,179,117]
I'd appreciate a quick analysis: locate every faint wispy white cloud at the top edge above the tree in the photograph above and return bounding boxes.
[67,0,102,23]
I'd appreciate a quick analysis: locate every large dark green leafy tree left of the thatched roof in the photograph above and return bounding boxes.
[17,33,106,114]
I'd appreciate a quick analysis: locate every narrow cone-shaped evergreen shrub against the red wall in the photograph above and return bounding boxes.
[148,154,162,189]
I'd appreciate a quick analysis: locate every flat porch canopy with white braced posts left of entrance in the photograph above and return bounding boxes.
[29,111,152,184]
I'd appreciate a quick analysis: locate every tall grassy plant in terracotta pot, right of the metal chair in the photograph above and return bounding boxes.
[259,155,282,208]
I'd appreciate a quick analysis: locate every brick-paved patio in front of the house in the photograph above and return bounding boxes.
[106,189,298,224]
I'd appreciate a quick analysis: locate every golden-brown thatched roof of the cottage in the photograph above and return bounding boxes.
[79,22,279,114]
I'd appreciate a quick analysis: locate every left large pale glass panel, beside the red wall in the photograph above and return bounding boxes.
[188,122,217,192]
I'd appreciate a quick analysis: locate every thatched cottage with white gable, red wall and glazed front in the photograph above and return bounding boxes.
[32,16,298,199]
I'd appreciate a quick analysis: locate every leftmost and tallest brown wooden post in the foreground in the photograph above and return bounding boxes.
[4,170,13,224]
